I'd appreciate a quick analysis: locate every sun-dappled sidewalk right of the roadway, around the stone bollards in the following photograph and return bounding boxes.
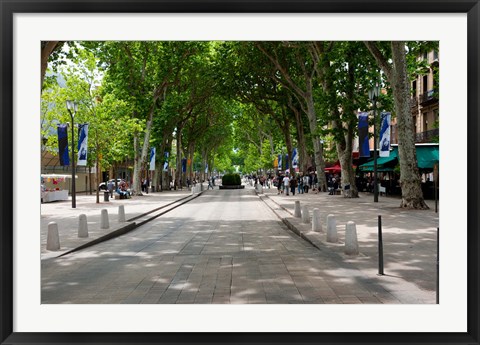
[260,188,439,292]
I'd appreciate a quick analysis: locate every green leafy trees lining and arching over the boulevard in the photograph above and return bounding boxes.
[42,41,438,209]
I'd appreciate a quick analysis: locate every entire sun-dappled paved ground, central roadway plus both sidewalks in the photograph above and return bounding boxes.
[42,186,438,304]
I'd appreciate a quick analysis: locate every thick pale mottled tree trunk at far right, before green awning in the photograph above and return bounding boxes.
[391,41,428,209]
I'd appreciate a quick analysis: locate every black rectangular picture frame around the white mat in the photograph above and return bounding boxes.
[0,0,480,344]
